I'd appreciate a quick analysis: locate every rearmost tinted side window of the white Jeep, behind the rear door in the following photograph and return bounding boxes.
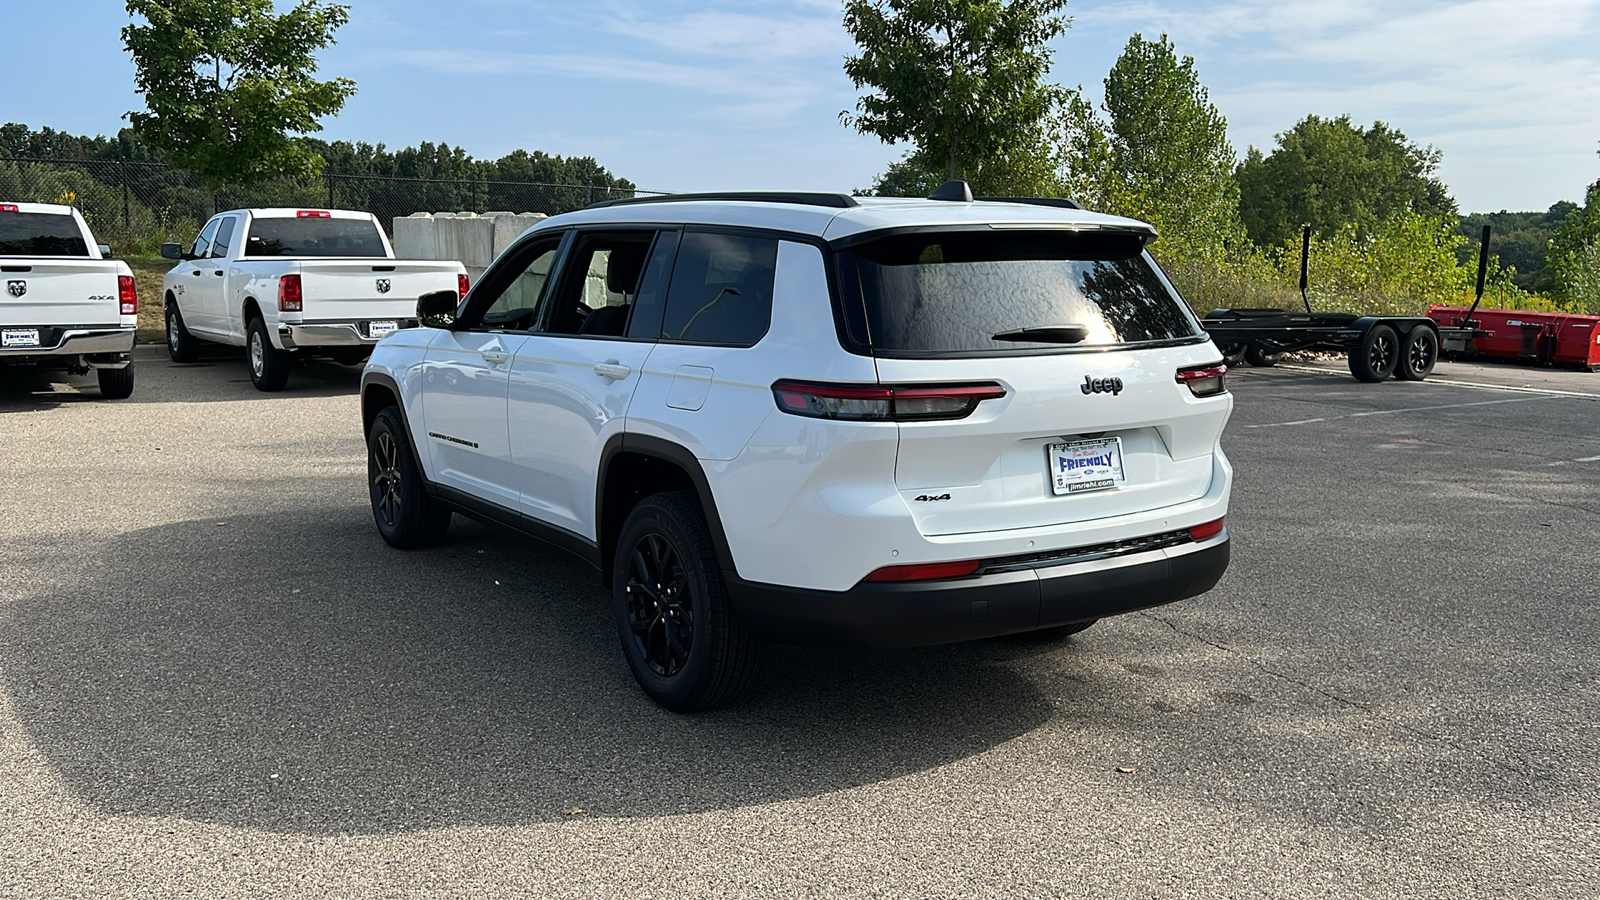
[661,231,778,346]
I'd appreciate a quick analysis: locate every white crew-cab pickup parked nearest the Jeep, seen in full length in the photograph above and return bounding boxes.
[162,208,467,391]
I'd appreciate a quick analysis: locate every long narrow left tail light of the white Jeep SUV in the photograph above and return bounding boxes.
[773,381,1005,421]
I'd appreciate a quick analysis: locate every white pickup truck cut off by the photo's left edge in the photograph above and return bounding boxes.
[0,203,139,400]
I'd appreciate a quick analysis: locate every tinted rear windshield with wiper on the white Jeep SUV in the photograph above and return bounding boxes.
[843,231,1200,354]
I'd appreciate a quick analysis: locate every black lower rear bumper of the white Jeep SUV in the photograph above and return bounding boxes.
[725,530,1230,647]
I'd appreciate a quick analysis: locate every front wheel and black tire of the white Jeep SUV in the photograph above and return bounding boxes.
[366,407,450,549]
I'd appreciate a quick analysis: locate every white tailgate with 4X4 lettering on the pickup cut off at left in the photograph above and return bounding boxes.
[0,259,122,327]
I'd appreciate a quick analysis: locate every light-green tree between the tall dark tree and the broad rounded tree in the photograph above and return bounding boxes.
[1064,34,1243,261]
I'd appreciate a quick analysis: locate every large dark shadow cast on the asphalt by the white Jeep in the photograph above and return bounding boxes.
[0,508,1053,833]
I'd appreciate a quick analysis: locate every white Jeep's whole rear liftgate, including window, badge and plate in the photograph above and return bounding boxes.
[842,229,1230,535]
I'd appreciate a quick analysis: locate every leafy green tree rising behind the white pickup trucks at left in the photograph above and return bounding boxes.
[122,0,355,199]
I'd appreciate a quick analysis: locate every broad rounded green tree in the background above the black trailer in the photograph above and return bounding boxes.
[1238,115,1456,247]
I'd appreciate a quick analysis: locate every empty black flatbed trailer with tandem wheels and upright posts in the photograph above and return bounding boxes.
[1200,226,1493,381]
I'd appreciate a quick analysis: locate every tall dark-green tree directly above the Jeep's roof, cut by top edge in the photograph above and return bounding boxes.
[840,0,1070,194]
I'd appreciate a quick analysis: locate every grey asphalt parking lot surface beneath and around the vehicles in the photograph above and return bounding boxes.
[0,341,1600,900]
